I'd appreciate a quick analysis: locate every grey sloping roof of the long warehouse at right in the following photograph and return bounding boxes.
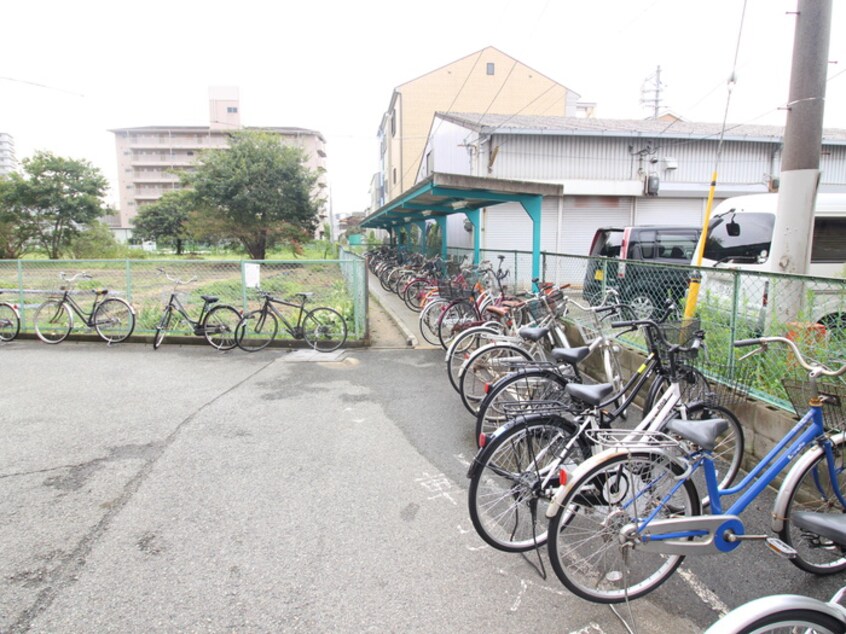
[438,112,846,144]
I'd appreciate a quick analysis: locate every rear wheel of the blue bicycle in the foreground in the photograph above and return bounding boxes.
[548,450,701,603]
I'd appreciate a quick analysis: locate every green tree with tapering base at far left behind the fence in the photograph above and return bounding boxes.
[5,152,108,260]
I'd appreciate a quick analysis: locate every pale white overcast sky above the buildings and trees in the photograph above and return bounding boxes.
[0,0,846,214]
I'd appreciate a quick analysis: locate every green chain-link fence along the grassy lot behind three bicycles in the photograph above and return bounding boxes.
[0,252,367,341]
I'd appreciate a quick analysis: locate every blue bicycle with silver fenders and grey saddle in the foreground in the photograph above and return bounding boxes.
[547,337,846,603]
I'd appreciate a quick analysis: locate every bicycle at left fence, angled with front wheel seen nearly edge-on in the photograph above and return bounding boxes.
[153,269,241,350]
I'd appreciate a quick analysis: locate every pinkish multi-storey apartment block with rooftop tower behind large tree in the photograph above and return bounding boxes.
[108,88,329,235]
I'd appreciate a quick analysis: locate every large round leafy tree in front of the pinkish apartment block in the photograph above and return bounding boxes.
[184,131,320,260]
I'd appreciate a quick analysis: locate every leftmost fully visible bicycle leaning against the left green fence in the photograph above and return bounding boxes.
[33,272,135,345]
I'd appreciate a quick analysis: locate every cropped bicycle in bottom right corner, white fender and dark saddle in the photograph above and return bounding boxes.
[705,512,846,634]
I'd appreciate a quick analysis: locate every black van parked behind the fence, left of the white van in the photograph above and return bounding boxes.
[583,225,702,319]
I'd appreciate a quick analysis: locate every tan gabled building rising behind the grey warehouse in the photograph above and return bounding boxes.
[371,46,592,209]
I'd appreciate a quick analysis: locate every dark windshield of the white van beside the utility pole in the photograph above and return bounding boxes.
[704,212,775,262]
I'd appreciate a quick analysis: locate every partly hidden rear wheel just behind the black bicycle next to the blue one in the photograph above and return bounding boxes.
[476,368,573,443]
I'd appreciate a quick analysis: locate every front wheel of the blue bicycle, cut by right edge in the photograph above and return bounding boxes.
[778,440,846,575]
